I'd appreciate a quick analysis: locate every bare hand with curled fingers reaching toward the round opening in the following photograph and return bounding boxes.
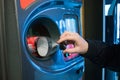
[57,31,88,54]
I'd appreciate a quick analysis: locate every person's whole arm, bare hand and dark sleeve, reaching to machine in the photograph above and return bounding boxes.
[57,32,120,71]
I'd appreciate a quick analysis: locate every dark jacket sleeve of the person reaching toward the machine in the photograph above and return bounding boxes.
[83,40,120,72]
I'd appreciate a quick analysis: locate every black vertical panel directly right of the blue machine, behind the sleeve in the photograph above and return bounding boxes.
[84,0,103,80]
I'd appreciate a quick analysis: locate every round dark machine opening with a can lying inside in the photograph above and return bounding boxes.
[25,17,60,60]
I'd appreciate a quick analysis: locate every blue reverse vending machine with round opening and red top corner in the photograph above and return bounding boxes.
[16,0,84,80]
